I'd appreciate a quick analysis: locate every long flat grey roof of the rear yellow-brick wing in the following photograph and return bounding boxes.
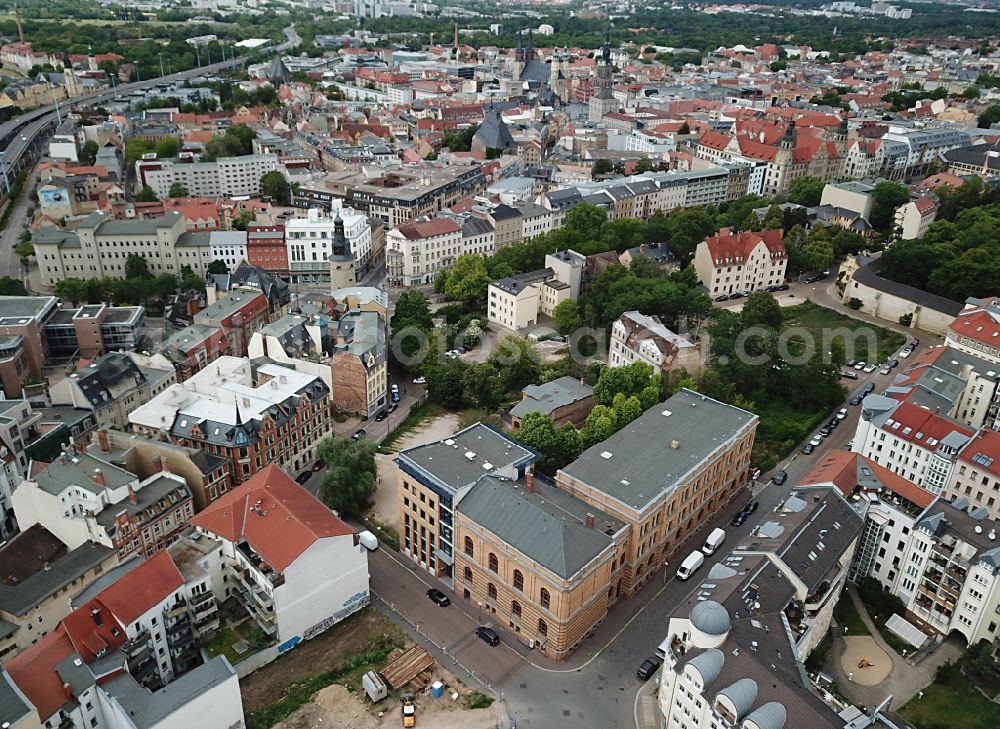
[563,389,757,509]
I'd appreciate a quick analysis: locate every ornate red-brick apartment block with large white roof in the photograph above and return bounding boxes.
[129,356,331,484]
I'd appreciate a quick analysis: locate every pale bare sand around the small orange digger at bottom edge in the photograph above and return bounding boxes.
[275,684,497,729]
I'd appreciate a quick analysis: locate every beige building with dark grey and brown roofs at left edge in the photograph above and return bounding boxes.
[0,524,118,663]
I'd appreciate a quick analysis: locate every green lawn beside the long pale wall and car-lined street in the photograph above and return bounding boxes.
[781,301,906,362]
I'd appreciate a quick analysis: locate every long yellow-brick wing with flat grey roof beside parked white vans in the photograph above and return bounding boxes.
[556,389,757,601]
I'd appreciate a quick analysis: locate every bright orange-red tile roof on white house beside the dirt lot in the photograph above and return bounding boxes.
[191,464,353,572]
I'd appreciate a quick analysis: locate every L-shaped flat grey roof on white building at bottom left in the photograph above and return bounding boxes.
[101,656,236,729]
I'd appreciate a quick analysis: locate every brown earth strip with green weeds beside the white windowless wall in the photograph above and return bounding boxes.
[240,608,399,714]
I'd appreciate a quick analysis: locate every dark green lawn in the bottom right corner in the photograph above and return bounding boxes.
[899,670,1000,729]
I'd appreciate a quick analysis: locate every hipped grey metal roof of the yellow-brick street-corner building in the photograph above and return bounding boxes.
[457,476,624,579]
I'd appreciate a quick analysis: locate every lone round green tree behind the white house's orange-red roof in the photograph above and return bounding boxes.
[316,438,377,519]
